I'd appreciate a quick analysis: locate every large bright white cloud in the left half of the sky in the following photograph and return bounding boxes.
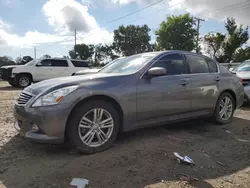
[0,0,113,52]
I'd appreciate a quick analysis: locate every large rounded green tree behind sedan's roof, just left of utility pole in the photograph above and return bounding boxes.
[155,14,197,51]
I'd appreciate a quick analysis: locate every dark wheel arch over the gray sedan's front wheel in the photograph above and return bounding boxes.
[64,95,123,139]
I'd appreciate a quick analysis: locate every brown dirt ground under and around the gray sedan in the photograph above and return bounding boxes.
[0,82,250,188]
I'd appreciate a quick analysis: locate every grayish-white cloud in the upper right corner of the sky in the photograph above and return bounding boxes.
[169,0,250,25]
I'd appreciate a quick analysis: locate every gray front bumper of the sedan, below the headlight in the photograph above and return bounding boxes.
[14,104,70,144]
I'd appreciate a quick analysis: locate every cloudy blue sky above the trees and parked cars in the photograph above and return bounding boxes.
[0,0,250,59]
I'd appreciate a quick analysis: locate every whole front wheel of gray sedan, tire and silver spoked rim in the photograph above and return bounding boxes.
[67,100,120,154]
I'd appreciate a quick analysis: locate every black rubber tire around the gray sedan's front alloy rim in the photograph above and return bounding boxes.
[66,100,120,154]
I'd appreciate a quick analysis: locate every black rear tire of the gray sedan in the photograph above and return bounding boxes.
[213,92,236,125]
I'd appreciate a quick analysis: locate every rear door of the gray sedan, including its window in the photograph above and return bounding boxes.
[185,54,220,113]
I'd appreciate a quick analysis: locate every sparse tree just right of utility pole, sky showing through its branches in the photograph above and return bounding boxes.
[204,32,226,59]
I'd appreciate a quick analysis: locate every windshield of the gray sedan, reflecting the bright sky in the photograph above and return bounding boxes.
[99,54,154,74]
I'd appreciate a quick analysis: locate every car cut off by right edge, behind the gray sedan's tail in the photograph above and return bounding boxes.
[229,60,250,101]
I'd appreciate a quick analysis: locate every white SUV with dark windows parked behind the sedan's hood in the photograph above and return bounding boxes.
[0,58,89,88]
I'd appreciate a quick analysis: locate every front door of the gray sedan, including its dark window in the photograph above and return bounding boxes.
[137,53,192,123]
